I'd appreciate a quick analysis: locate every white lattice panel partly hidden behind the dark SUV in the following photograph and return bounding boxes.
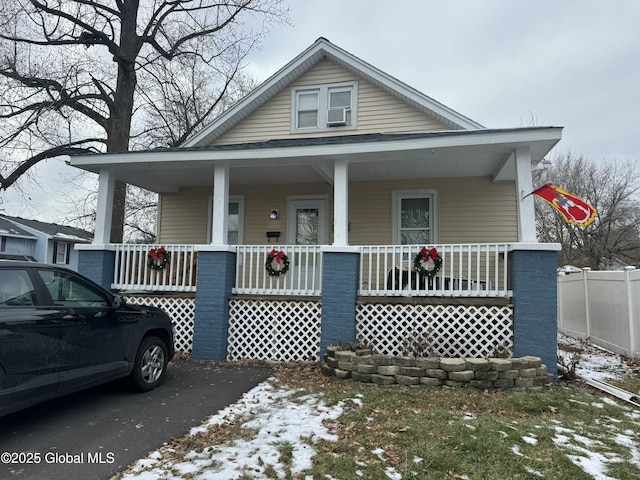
[125,296,196,352]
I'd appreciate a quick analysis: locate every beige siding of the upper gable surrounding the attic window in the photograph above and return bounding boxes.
[214,60,449,145]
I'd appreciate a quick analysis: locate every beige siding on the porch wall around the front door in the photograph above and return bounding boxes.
[158,177,518,245]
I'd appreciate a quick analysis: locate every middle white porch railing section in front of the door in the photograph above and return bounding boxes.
[233,245,322,296]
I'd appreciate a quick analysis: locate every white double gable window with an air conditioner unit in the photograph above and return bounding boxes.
[291,82,357,133]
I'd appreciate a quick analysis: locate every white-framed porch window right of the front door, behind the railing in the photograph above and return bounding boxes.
[393,190,437,245]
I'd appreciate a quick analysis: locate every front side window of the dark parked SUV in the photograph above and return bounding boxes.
[38,270,109,307]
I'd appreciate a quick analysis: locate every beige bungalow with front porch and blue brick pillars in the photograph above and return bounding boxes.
[71,38,562,372]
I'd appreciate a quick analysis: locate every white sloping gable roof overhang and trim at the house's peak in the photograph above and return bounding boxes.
[182,37,484,147]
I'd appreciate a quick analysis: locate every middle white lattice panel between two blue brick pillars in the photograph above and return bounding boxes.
[227,299,321,362]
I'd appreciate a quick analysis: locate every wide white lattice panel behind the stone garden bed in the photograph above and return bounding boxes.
[356,303,513,358]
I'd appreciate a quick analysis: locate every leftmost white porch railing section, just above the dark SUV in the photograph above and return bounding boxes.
[111,244,198,292]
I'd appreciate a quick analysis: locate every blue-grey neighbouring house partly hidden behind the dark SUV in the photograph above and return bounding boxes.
[0,215,93,270]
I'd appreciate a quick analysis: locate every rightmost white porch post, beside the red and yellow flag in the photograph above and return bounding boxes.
[515,147,538,243]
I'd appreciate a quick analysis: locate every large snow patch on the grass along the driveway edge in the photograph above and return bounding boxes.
[123,379,359,480]
